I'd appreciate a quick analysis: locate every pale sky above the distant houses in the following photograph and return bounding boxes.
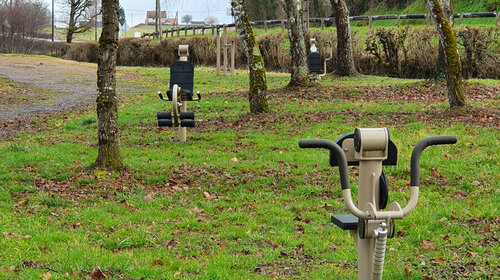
[44,0,232,26]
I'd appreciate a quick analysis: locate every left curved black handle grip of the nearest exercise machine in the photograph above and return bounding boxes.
[299,140,350,190]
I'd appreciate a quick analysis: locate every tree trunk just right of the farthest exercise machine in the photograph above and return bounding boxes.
[330,0,358,76]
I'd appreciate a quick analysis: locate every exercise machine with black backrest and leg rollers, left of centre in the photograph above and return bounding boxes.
[156,45,201,142]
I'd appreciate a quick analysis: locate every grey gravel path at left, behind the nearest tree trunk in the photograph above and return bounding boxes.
[0,55,145,136]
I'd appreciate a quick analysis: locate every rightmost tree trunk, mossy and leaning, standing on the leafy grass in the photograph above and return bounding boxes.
[425,0,467,108]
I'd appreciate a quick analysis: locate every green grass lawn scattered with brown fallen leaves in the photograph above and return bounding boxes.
[0,55,500,279]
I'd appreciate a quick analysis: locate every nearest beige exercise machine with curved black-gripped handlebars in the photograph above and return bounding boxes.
[299,128,457,280]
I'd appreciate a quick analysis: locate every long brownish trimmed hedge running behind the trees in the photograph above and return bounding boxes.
[0,27,500,79]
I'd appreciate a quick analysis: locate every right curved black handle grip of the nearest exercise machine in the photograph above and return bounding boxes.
[410,135,457,187]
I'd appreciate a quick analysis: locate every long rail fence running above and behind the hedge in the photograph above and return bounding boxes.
[141,11,500,38]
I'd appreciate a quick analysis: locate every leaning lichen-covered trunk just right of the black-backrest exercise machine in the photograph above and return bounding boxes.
[231,0,269,114]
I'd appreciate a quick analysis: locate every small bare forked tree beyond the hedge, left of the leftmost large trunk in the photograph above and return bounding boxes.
[62,0,99,43]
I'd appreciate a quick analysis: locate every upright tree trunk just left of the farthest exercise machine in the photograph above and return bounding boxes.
[285,0,309,87]
